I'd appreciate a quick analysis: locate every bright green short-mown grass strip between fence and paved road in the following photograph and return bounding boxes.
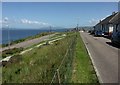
[71,33,98,85]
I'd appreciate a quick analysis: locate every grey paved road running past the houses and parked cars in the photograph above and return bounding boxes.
[80,32,118,83]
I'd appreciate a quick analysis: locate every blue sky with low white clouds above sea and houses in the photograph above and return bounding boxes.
[2,2,118,28]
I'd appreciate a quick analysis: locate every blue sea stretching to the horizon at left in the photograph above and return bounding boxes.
[0,29,66,44]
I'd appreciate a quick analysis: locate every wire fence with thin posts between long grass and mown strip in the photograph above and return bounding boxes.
[50,33,77,85]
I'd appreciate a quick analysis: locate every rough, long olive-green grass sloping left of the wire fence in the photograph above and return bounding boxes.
[2,32,74,83]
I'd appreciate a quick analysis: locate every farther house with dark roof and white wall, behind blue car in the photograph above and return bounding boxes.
[95,12,117,36]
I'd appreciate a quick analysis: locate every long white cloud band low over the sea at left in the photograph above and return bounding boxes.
[0,17,53,28]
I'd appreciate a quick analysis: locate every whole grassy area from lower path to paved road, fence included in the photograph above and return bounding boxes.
[2,32,98,83]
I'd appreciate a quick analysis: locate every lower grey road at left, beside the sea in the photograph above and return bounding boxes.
[0,34,55,52]
